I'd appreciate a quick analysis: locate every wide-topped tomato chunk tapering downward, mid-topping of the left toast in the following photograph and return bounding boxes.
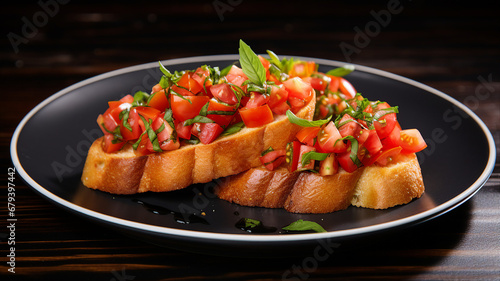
[170,95,210,122]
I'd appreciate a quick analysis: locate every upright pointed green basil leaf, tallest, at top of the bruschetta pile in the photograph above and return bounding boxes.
[239,40,266,86]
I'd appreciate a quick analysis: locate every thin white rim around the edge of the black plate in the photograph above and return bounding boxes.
[10,55,496,242]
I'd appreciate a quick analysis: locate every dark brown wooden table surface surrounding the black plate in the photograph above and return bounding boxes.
[0,0,500,280]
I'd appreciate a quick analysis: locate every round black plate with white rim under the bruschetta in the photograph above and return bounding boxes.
[11,55,495,254]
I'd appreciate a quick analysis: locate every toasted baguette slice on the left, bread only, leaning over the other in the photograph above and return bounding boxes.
[81,89,316,194]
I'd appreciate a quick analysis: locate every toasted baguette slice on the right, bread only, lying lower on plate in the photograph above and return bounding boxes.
[216,153,424,213]
